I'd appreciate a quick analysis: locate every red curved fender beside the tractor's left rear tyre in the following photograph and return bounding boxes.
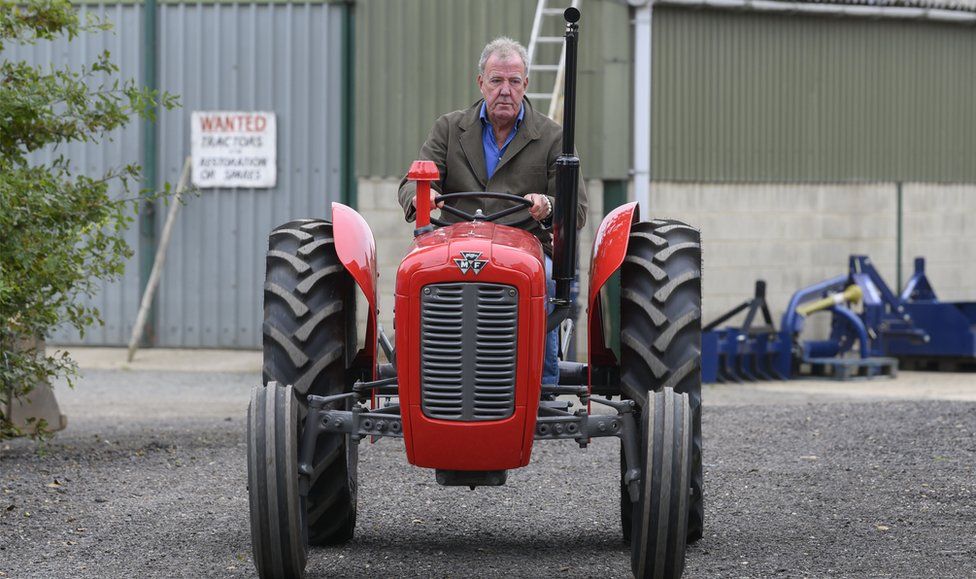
[332,203,378,380]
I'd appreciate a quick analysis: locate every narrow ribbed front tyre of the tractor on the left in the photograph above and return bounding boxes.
[247,382,308,577]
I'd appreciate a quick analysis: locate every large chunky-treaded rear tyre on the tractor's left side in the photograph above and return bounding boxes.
[263,219,357,545]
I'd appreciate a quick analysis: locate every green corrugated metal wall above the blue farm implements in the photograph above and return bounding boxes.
[651,8,976,182]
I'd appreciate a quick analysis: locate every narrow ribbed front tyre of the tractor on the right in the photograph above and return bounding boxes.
[630,388,692,579]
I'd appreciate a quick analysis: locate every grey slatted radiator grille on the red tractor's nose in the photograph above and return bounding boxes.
[420,283,518,421]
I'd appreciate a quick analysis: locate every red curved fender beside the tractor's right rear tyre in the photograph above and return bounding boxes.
[587,202,640,368]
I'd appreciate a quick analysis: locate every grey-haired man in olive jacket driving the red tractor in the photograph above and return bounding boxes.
[399,36,587,384]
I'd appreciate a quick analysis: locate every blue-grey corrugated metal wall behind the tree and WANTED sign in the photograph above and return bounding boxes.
[5,2,342,348]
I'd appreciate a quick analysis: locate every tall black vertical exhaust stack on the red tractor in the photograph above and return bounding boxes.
[547,7,580,332]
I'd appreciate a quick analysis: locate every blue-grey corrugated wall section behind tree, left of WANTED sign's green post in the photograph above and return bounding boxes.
[2,5,142,345]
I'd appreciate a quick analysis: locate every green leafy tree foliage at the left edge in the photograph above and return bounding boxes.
[0,0,177,439]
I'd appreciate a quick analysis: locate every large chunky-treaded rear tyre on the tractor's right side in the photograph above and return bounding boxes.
[620,219,705,543]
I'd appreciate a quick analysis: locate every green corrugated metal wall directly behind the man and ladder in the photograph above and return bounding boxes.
[356,0,631,179]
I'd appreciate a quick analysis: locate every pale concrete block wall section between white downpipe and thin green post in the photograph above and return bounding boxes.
[650,183,897,326]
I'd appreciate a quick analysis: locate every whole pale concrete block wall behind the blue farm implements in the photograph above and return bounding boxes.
[645,183,976,335]
